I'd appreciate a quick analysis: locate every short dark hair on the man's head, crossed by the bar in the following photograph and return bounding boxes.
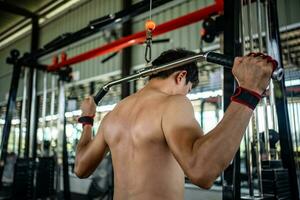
[149,48,199,87]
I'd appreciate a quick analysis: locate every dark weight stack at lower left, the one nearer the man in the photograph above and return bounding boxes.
[36,157,55,198]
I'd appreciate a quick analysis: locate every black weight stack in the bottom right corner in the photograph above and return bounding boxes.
[262,161,291,200]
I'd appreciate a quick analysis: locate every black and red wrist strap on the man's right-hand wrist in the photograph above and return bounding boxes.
[231,87,262,110]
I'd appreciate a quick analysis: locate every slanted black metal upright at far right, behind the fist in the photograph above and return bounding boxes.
[266,0,299,200]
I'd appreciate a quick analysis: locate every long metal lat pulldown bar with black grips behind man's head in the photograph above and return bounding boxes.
[94,52,283,104]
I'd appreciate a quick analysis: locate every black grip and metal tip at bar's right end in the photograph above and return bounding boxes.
[206,52,284,81]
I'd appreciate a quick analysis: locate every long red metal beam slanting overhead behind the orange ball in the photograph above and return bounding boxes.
[47,0,223,71]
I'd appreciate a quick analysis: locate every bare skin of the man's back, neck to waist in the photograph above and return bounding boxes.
[102,89,184,200]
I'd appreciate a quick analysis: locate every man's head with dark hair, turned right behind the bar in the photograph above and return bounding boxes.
[149,49,199,93]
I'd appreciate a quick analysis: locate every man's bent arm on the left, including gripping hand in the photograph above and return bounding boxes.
[75,97,108,178]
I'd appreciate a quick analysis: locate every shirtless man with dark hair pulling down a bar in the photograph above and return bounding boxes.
[75,50,272,200]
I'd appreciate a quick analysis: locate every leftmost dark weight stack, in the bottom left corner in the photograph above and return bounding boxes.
[12,158,35,199]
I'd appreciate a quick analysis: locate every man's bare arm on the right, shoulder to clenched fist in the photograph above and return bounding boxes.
[162,54,272,188]
